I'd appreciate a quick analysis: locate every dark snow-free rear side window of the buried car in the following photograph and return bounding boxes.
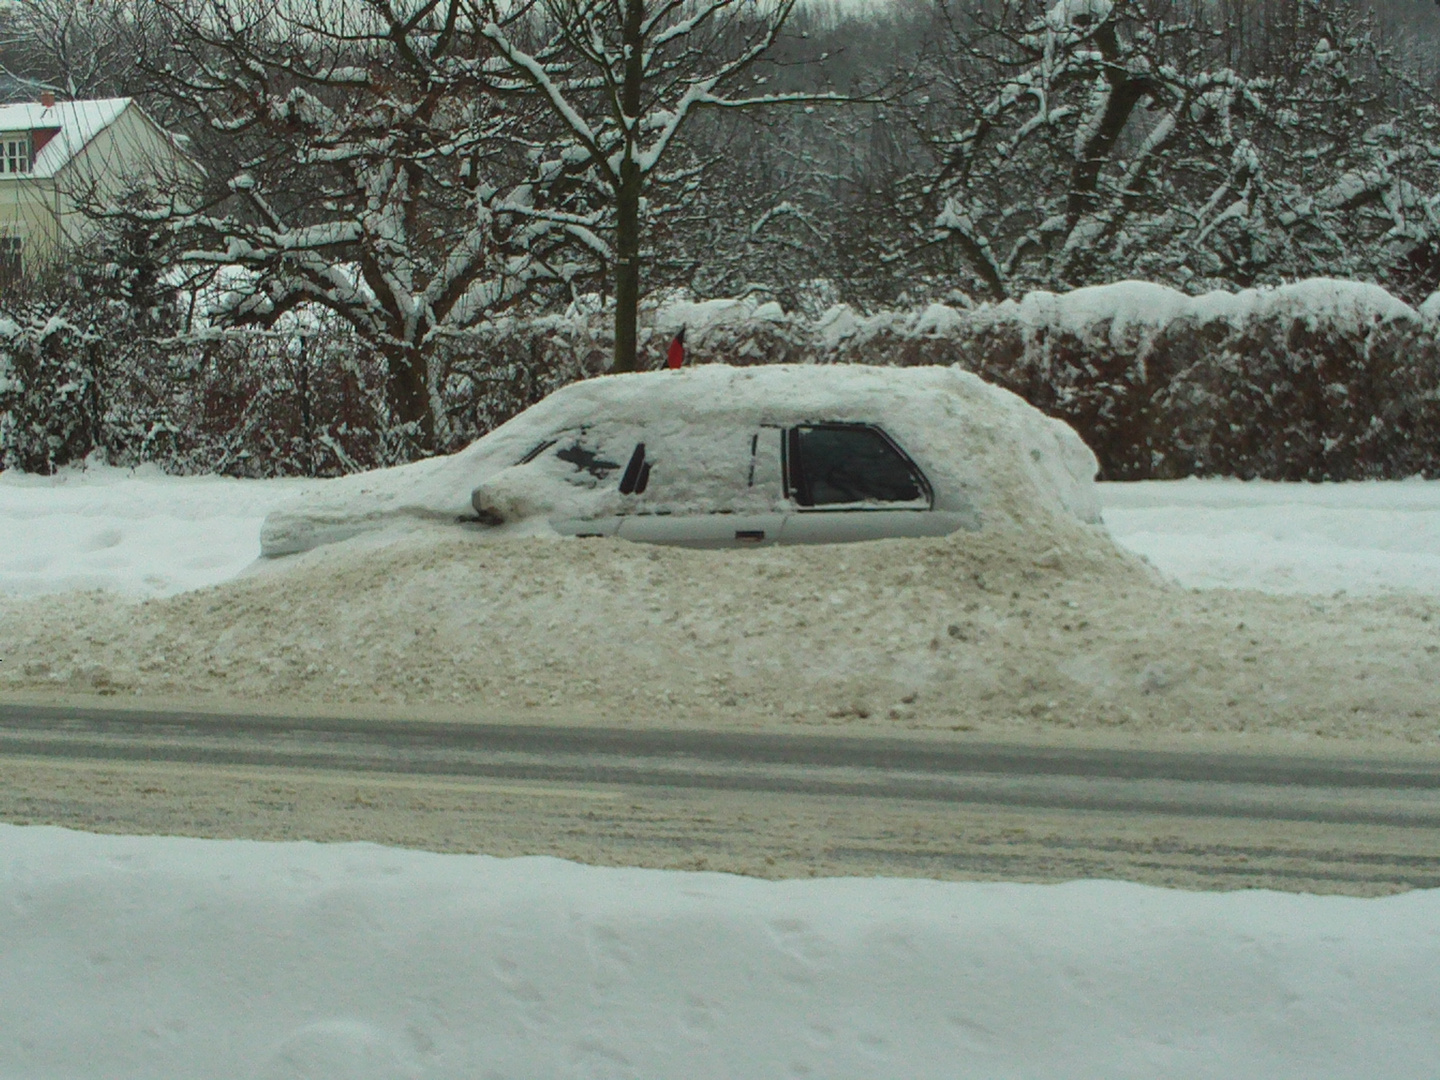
[785,423,930,507]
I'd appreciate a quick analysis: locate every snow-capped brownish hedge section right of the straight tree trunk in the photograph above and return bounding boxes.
[639,279,1440,481]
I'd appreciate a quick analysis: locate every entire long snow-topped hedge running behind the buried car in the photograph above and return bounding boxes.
[0,279,1440,480]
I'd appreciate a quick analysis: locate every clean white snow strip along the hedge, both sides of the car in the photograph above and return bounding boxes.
[0,467,1440,596]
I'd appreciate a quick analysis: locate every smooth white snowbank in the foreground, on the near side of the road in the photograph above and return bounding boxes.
[0,825,1440,1080]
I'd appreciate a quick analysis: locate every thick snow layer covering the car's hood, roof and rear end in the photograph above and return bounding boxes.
[261,364,1100,556]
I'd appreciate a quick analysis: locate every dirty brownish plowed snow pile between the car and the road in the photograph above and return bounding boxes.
[0,518,1440,740]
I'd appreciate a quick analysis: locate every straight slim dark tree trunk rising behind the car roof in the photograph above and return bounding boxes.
[611,0,645,372]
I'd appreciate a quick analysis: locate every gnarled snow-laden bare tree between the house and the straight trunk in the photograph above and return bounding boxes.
[128,0,576,452]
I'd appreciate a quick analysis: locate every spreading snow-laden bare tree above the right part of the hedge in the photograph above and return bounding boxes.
[864,0,1440,298]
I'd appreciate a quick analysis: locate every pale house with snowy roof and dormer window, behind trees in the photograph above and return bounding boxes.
[0,94,203,276]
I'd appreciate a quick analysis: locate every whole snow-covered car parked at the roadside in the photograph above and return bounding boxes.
[262,364,1099,554]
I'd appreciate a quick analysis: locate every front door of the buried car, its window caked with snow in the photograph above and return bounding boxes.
[618,428,785,547]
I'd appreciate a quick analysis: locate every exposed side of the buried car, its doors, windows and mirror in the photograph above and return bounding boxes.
[471,410,981,547]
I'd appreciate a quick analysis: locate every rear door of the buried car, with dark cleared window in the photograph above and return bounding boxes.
[780,423,962,544]
